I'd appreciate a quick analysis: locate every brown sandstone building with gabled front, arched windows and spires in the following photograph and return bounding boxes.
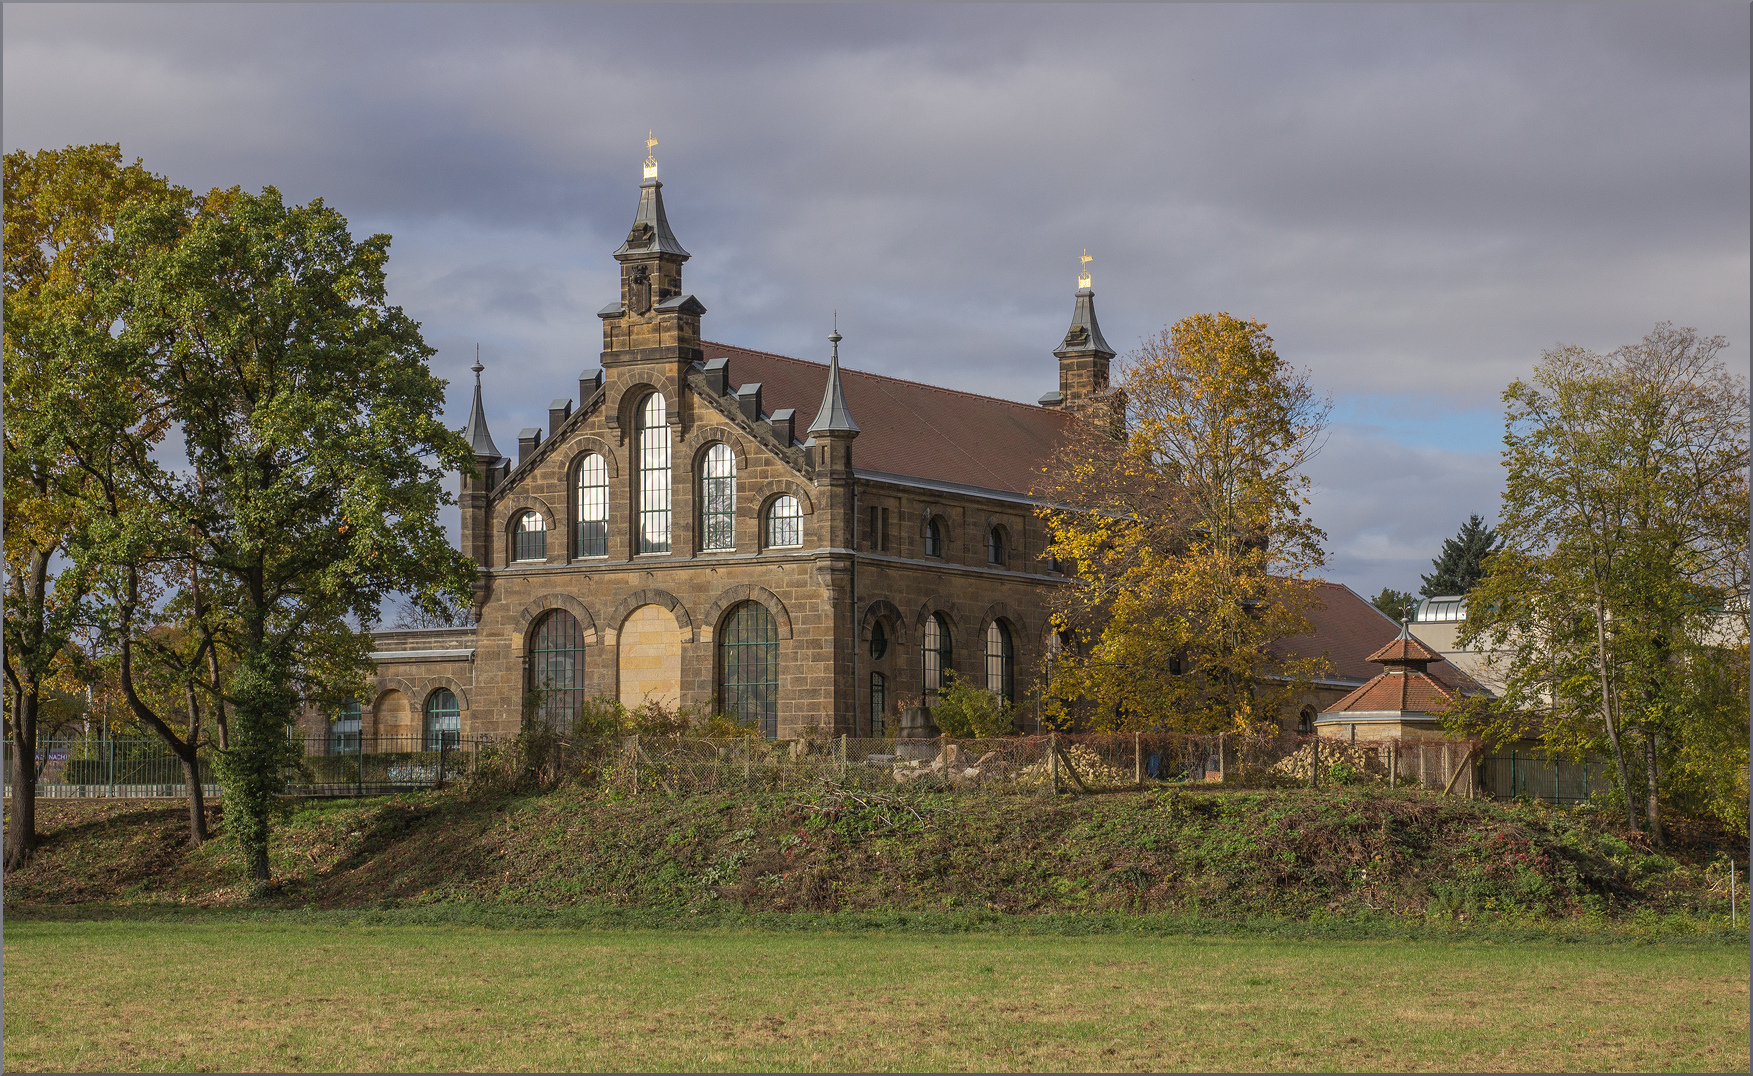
[359,151,1423,750]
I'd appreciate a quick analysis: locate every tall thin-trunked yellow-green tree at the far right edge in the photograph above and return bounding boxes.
[1460,322,1749,843]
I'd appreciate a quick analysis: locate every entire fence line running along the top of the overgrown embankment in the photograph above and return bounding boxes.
[5,733,1584,804]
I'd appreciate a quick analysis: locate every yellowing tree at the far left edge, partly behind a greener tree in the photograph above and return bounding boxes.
[4,145,188,871]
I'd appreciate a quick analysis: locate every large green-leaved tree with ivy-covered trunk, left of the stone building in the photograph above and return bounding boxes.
[77,188,473,883]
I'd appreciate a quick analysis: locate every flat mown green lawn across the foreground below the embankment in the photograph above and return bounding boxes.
[5,920,1748,1071]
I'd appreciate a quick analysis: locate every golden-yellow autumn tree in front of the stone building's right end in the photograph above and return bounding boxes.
[1041,314,1329,733]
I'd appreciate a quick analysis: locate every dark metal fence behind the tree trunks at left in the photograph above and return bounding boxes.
[5,734,493,799]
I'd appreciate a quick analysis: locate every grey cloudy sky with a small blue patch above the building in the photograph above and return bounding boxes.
[4,4,1749,594]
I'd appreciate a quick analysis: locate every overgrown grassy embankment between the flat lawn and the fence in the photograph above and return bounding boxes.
[5,785,1744,924]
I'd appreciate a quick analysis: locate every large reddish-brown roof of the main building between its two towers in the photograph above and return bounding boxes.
[701,343,1076,494]
